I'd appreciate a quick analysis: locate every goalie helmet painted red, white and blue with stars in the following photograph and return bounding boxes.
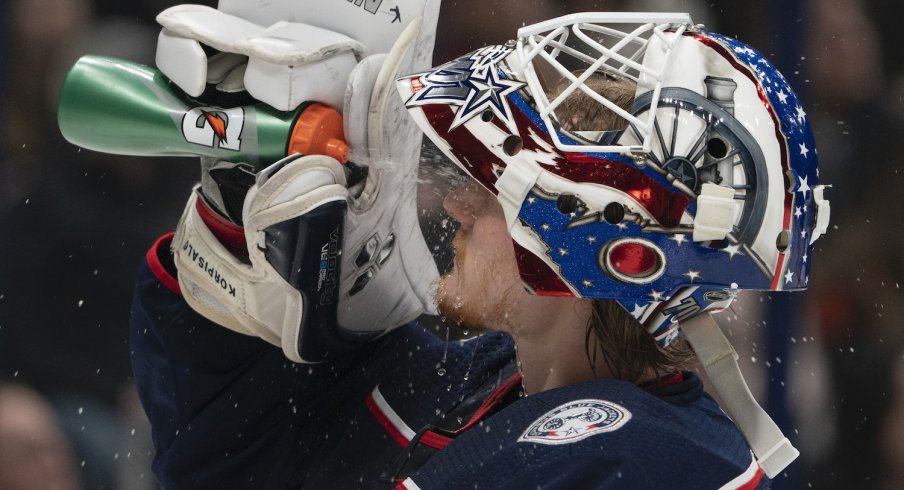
[398,13,829,345]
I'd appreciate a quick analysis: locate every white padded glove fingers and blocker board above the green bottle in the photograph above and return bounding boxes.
[156,0,440,111]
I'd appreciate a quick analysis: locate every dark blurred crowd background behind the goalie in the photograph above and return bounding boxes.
[0,0,904,490]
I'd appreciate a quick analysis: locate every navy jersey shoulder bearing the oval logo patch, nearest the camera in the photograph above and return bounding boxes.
[415,375,762,488]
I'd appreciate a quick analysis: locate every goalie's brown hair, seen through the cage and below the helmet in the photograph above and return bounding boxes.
[547,73,693,383]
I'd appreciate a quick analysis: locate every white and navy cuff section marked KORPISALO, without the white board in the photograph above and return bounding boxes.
[173,155,348,362]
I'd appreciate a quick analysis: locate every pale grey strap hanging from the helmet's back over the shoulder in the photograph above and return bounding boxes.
[681,313,800,478]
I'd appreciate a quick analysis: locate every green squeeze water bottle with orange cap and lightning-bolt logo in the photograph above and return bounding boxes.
[57,56,348,170]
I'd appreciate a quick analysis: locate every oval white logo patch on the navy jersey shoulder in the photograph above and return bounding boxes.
[518,400,631,444]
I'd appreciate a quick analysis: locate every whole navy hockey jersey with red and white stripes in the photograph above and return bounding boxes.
[131,237,768,489]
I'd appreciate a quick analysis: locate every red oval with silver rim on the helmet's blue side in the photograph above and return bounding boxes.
[600,238,665,284]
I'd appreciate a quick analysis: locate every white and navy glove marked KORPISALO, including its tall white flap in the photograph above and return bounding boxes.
[169,5,438,362]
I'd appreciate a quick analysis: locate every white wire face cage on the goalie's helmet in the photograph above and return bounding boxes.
[516,13,693,154]
